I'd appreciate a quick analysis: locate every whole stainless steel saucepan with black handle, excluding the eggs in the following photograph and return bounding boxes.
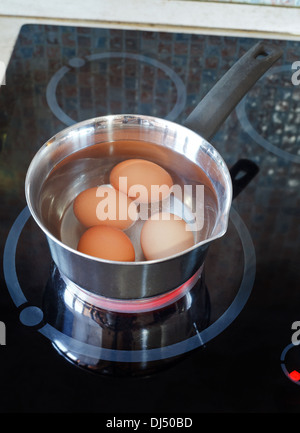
[25,43,281,300]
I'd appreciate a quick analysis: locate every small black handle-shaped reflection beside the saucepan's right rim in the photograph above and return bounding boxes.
[229,159,259,199]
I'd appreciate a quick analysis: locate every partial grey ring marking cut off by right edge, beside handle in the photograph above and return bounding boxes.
[236,65,300,163]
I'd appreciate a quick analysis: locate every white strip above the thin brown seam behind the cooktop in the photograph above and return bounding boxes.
[0,0,300,35]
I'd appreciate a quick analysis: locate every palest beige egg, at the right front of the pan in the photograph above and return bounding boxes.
[141,212,194,260]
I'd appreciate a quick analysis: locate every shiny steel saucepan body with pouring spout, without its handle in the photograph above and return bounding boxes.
[25,115,232,299]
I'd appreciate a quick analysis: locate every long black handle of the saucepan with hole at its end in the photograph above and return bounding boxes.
[184,42,282,141]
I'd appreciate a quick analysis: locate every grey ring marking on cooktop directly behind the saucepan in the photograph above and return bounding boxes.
[46,52,186,126]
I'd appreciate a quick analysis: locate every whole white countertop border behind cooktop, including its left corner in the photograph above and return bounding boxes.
[0,0,300,83]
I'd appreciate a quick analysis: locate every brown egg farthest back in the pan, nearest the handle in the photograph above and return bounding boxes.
[110,159,173,203]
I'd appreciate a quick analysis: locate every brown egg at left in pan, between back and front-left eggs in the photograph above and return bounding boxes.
[73,186,137,230]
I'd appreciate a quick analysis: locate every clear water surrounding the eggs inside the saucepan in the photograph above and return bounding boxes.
[40,140,218,261]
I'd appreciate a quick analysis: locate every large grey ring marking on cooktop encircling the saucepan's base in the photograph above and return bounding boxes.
[4,202,256,362]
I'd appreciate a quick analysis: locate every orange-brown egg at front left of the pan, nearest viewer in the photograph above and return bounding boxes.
[77,225,135,262]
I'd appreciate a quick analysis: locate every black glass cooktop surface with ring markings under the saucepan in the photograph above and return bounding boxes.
[0,25,300,416]
